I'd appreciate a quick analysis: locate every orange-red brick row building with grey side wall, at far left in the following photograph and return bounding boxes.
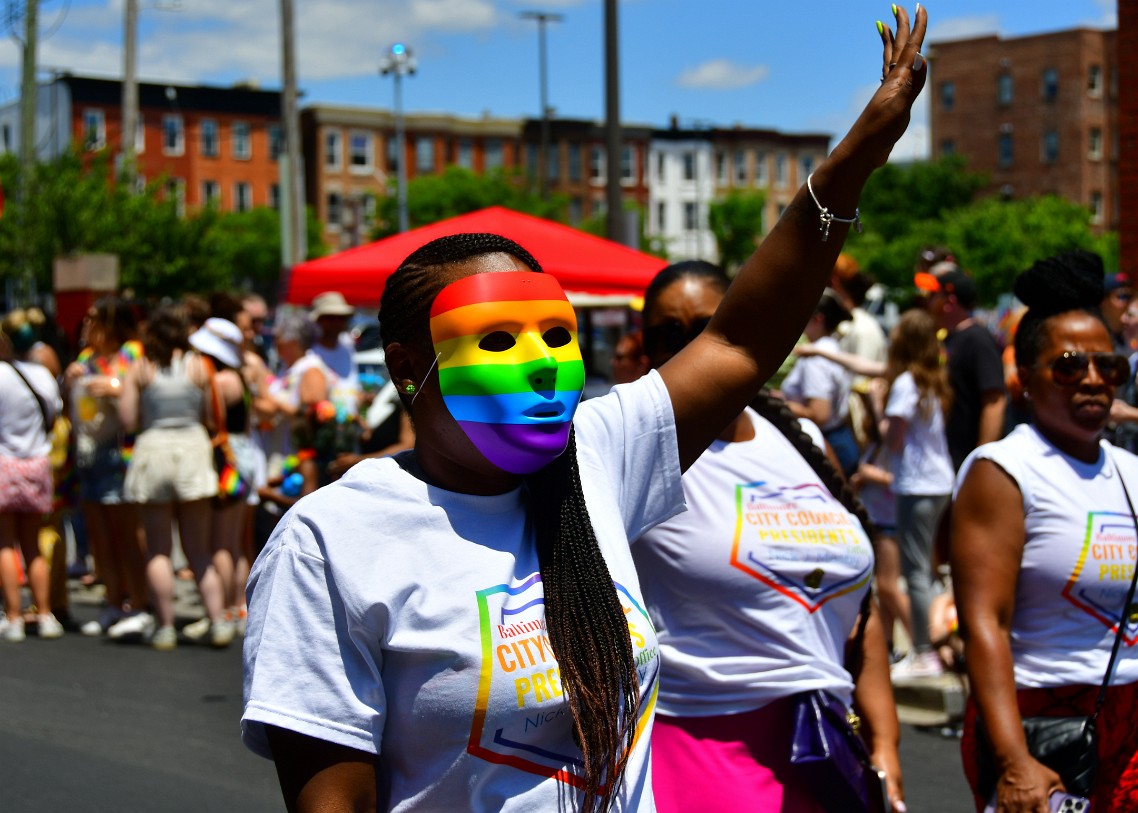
[0,74,282,212]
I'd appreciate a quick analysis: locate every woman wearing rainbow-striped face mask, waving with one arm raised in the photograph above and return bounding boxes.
[242,9,926,812]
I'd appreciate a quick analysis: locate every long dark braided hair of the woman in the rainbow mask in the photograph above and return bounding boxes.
[379,233,640,813]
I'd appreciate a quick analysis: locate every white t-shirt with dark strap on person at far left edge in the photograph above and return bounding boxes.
[0,361,63,458]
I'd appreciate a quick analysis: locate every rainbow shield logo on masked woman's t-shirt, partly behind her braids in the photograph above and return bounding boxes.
[467,573,660,787]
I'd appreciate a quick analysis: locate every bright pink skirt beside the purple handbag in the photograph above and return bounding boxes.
[652,698,825,813]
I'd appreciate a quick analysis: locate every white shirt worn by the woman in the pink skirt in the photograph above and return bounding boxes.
[633,410,873,717]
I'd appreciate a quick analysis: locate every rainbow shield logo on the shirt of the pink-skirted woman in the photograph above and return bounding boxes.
[731,481,873,613]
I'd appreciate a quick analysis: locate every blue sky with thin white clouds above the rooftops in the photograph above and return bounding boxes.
[0,0,1116,158]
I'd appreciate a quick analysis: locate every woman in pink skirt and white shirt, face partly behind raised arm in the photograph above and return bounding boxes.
[633,262,904,813]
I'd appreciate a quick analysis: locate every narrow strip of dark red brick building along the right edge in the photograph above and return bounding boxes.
[1118,2,1138,279]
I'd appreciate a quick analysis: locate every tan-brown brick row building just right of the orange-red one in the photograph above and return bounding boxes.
[300,105,521,251]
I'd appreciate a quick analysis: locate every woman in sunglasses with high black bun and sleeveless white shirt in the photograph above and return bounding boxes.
[951,251,1138,813]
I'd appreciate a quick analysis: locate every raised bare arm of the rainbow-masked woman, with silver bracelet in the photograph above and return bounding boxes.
[660,6,927,468]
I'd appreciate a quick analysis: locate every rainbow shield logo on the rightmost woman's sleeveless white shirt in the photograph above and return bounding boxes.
[1063,511,1138,647]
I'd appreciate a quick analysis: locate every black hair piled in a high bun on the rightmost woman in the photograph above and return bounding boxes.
[1013,248,1105,367]
